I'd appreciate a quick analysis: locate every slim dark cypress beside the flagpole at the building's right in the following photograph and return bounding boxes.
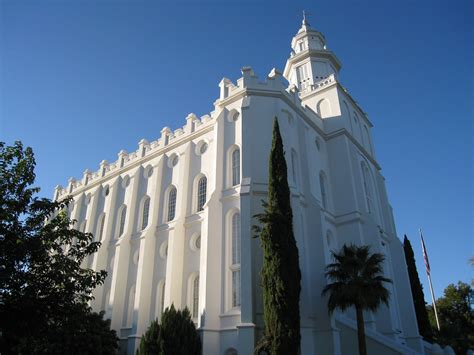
[403,235,433,340]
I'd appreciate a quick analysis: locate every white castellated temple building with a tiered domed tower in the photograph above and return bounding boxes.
[55,20,430,355]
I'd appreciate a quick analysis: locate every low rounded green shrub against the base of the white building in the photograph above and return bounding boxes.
[137,305,201,355]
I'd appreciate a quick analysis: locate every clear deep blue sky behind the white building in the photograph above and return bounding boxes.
[0,0,474,299]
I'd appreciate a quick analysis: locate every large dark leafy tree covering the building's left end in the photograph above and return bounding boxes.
[0,142,117,354]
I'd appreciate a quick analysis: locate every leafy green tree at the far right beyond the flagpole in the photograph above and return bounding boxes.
[428,282,474,354]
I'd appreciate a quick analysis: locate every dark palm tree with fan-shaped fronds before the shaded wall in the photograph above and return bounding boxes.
[322,244,392,355]
